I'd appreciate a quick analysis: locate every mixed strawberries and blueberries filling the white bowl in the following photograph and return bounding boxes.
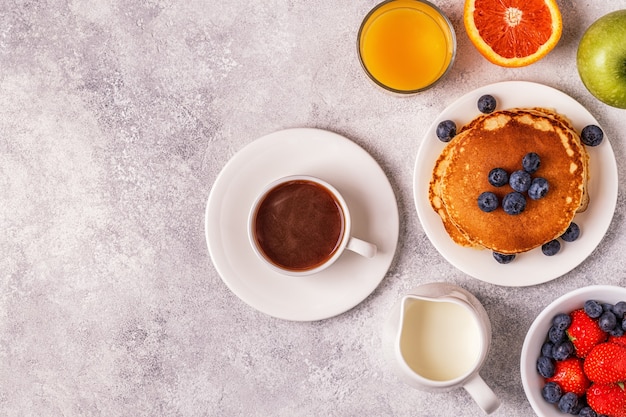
[537,300,626,417]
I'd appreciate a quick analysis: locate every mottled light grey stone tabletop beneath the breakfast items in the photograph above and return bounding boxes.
[0,0,626,417]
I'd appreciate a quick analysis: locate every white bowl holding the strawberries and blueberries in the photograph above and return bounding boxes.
[520,285,626,417]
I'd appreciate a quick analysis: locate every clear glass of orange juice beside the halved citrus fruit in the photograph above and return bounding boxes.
[358,0,456,95]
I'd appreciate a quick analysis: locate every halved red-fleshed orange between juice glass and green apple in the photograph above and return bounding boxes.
[463,0,563,67]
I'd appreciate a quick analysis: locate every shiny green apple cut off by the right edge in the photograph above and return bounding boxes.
[576,10,626,109]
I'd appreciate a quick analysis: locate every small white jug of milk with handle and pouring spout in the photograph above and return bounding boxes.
[383,283,500,414]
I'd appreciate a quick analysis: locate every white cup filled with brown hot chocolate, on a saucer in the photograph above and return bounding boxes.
[248,175,377,276]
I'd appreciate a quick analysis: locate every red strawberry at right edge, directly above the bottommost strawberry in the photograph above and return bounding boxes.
[584,342,626,384]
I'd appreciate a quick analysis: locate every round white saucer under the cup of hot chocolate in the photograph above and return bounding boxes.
[205,128,399,321]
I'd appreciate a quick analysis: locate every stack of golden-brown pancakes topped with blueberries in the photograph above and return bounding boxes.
[429,108,589,254]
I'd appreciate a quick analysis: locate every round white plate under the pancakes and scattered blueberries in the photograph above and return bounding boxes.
[413,81,617,286]
